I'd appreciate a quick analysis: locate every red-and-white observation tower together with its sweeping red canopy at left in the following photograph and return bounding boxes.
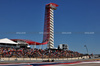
[11,3,58,49]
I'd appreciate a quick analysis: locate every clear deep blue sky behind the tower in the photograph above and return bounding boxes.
[0,0,100,53]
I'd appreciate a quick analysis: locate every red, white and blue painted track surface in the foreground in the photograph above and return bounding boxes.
[0,61,100,66]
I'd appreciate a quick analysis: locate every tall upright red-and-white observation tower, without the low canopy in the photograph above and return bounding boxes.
[43,3,58,48]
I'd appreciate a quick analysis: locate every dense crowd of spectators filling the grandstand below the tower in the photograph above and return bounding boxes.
[0,48,82,58]
